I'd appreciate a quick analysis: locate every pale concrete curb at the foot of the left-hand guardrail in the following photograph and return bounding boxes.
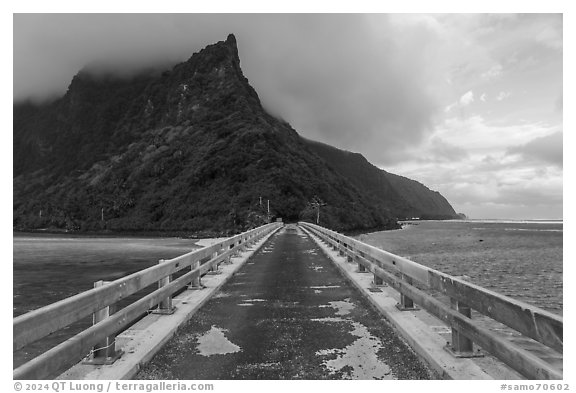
[57,227,282,380]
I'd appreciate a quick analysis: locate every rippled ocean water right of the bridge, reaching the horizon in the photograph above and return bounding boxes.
[357,220,563,315]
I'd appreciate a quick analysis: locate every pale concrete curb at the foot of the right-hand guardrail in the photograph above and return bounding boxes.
[300,227,522,380]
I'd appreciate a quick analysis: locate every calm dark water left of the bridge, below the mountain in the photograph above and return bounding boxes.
[13,233,198,367]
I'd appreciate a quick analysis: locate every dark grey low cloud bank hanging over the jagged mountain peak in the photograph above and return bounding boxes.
[14,14,438,165]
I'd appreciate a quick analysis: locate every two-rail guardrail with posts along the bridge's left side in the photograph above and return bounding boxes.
[13,223,282,379]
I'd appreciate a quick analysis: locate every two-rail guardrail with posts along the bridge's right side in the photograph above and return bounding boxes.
[299,222,563,379]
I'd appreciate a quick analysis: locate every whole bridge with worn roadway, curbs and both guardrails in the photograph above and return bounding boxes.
[13,222,563,380]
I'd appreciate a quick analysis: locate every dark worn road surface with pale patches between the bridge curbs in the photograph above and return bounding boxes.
[136,225,432,380]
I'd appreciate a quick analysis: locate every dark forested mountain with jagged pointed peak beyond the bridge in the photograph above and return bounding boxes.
[13,35,455,233]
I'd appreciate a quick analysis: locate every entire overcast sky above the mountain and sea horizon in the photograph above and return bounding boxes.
[13,14,563,218]
